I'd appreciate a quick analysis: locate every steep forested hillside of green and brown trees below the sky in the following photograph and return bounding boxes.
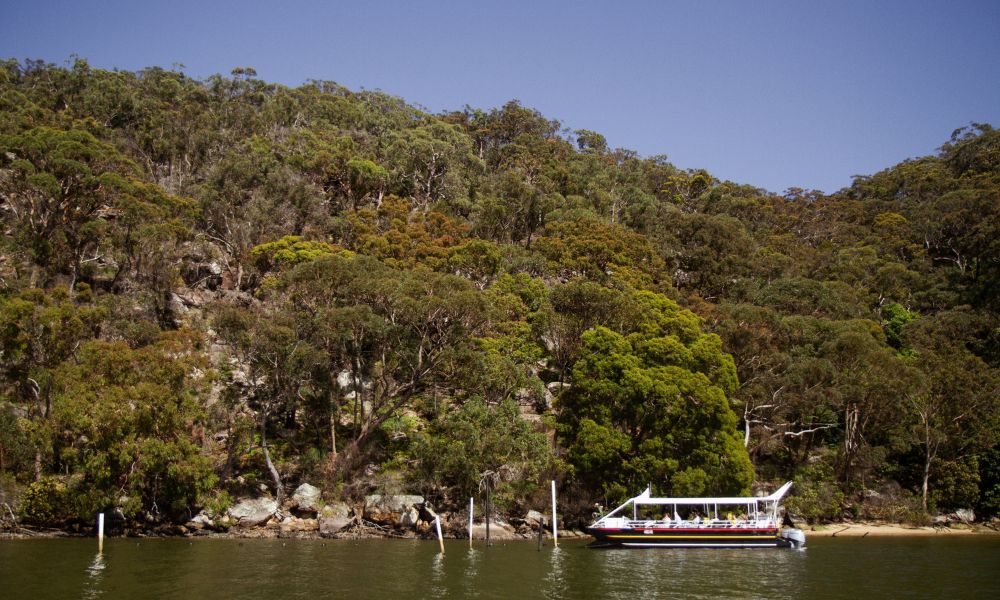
[0,60,1000,525]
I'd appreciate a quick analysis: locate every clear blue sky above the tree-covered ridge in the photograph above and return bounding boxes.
[0,0,1000,192]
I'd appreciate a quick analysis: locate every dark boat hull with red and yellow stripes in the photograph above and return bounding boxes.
[588,527,792,548]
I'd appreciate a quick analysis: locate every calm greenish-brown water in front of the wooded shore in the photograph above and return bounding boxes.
[0,536,1000,600]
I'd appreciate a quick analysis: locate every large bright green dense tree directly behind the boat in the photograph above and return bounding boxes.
[559,292,753,495]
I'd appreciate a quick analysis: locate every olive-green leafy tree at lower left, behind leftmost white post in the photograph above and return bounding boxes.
[46,339,216,516]
